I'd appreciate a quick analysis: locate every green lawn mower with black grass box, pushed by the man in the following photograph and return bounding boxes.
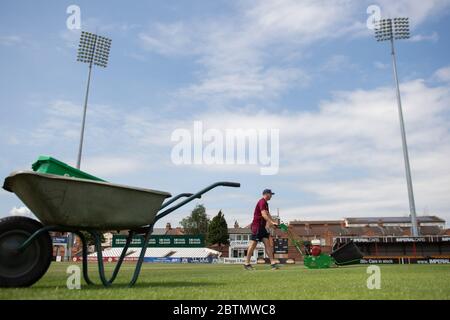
[279,223,363,269]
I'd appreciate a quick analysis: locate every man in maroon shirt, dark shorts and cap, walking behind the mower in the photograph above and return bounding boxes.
[244,189,278,270]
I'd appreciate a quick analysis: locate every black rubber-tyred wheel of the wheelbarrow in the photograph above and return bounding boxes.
[0,216,53,288]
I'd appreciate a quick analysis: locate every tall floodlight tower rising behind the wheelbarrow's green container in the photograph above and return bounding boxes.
[77,31,111,169]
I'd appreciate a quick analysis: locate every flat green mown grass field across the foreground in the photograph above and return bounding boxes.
[0,263,450,300]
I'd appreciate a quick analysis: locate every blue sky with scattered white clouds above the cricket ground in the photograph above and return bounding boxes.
[0,0,450,227]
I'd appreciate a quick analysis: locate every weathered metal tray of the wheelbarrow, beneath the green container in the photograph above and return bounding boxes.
[3,171,171,230]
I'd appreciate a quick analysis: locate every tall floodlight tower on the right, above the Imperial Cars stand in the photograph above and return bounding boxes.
[375,18,419,237]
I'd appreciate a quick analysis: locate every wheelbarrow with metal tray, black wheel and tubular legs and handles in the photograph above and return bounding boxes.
[0,171,240,287]
